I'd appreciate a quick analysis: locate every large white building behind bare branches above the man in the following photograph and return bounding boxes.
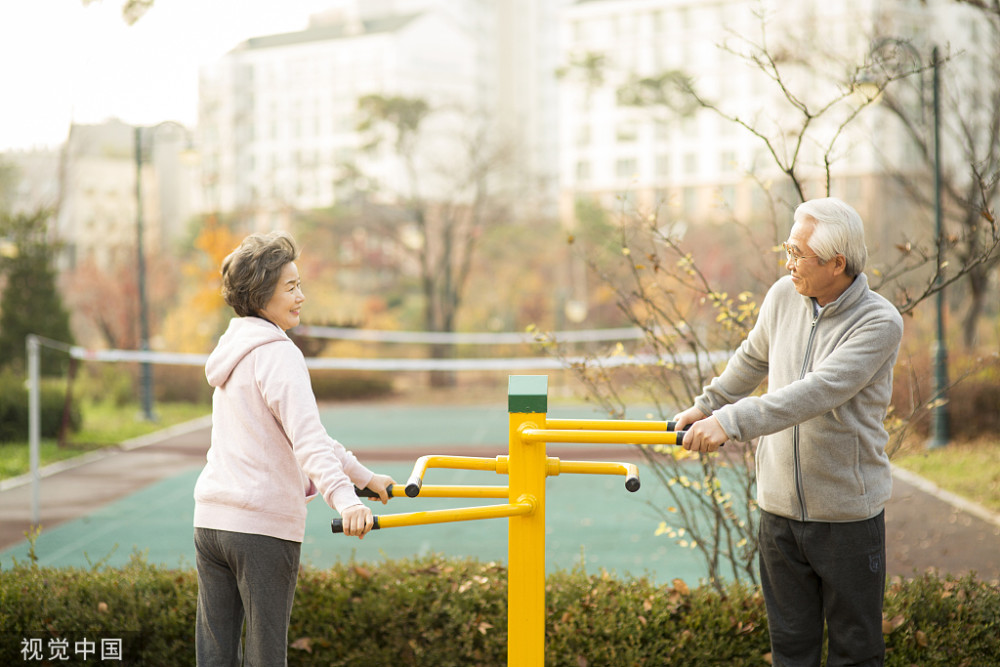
[560,0,981,248]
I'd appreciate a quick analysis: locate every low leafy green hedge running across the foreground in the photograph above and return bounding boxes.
[0,557,1000,667]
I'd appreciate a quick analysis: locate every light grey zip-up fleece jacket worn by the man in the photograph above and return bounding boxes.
[695,274,903,522]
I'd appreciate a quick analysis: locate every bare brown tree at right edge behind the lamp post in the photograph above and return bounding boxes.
[868,13,1000,349]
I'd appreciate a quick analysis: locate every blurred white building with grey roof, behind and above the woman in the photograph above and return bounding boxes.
[199,5,475,229]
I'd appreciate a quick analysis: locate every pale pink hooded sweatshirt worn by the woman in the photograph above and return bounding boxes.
[194,317,374,542]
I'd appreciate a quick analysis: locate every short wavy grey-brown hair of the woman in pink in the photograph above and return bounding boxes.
[222,232,299,317]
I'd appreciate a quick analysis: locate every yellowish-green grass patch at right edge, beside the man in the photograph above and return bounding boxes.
[892,438,1000,512]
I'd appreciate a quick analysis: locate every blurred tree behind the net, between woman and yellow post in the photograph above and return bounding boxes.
[345,95,510,383]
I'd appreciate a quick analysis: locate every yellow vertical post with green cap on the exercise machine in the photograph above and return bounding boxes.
[507,375,549,667]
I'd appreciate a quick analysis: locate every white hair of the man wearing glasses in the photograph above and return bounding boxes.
[795,197,868,277]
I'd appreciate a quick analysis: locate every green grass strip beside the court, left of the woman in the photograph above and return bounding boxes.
[0,403,212,479]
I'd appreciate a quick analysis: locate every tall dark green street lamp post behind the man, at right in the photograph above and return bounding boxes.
[859,37,950,449]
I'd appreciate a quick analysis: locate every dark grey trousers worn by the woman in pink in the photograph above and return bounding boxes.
[194,528,302,667]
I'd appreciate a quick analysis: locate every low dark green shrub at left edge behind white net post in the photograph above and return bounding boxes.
[0,370,82,442]
